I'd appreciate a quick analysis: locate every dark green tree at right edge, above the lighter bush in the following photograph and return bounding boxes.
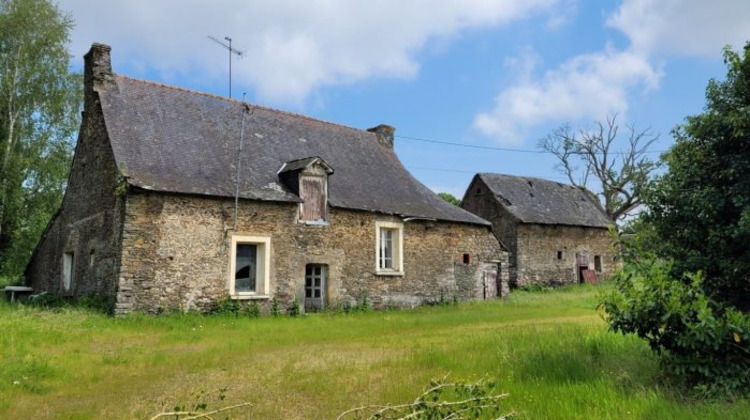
[645,43,750,311]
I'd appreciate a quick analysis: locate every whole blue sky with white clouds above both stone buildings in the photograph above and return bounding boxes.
[59,0,750,198]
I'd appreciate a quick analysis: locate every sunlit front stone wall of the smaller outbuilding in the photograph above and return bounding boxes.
[517,224,616,286]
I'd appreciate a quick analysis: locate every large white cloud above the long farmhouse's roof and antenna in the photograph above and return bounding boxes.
[60,0,558,104]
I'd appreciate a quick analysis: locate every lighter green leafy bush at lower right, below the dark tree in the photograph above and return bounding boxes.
[602,258,750,397]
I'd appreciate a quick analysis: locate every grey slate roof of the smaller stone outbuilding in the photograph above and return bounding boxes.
[477,173,613,228]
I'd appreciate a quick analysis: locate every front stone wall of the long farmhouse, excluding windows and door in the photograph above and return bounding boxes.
[117,192,507,313]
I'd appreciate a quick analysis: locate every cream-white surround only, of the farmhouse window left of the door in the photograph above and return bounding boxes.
[227,235,271,299]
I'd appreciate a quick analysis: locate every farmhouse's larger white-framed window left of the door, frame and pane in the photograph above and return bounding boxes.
[229,235,271,299]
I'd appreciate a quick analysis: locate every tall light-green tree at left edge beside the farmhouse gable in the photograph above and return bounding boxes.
[0,0,82,276]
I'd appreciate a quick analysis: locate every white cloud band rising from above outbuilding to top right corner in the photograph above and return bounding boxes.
[474,0,750,143]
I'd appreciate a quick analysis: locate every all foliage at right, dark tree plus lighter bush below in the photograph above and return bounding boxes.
[603,43,750,395]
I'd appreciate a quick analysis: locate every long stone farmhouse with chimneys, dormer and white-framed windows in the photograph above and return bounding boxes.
[25,44,508,314]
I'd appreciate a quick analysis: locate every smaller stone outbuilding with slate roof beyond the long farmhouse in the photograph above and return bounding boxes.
[461,173,616,286]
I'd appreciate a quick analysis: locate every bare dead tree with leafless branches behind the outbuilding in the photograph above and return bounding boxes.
[538,114,660,221]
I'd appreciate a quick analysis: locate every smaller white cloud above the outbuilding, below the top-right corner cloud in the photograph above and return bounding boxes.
[474,48,661,144]
